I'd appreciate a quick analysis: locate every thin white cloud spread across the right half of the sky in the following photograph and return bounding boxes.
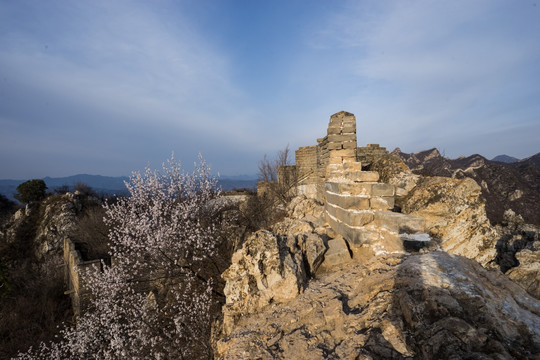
[304,1,540,156]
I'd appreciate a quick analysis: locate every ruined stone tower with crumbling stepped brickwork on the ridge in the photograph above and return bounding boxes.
[278,111,424,250]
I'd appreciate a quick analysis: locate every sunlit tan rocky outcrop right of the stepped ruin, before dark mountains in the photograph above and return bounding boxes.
[402,177,498,267]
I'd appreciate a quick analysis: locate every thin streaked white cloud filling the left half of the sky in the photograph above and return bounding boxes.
[0,2,266,176]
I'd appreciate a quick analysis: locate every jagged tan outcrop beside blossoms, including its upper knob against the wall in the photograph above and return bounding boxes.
[221,196,328,334]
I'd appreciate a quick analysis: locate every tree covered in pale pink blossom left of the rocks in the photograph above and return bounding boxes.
[19,157,218,359]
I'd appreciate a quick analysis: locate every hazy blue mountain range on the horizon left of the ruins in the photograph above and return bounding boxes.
[0,174,257,200]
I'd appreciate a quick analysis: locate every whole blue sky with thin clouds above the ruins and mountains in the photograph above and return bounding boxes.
[0,0,540,179]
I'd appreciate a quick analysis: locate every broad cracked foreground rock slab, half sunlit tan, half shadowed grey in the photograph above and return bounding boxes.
[216,251,540,359]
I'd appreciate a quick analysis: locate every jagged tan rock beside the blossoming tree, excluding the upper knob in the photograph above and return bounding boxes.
[222,230,307,333]
